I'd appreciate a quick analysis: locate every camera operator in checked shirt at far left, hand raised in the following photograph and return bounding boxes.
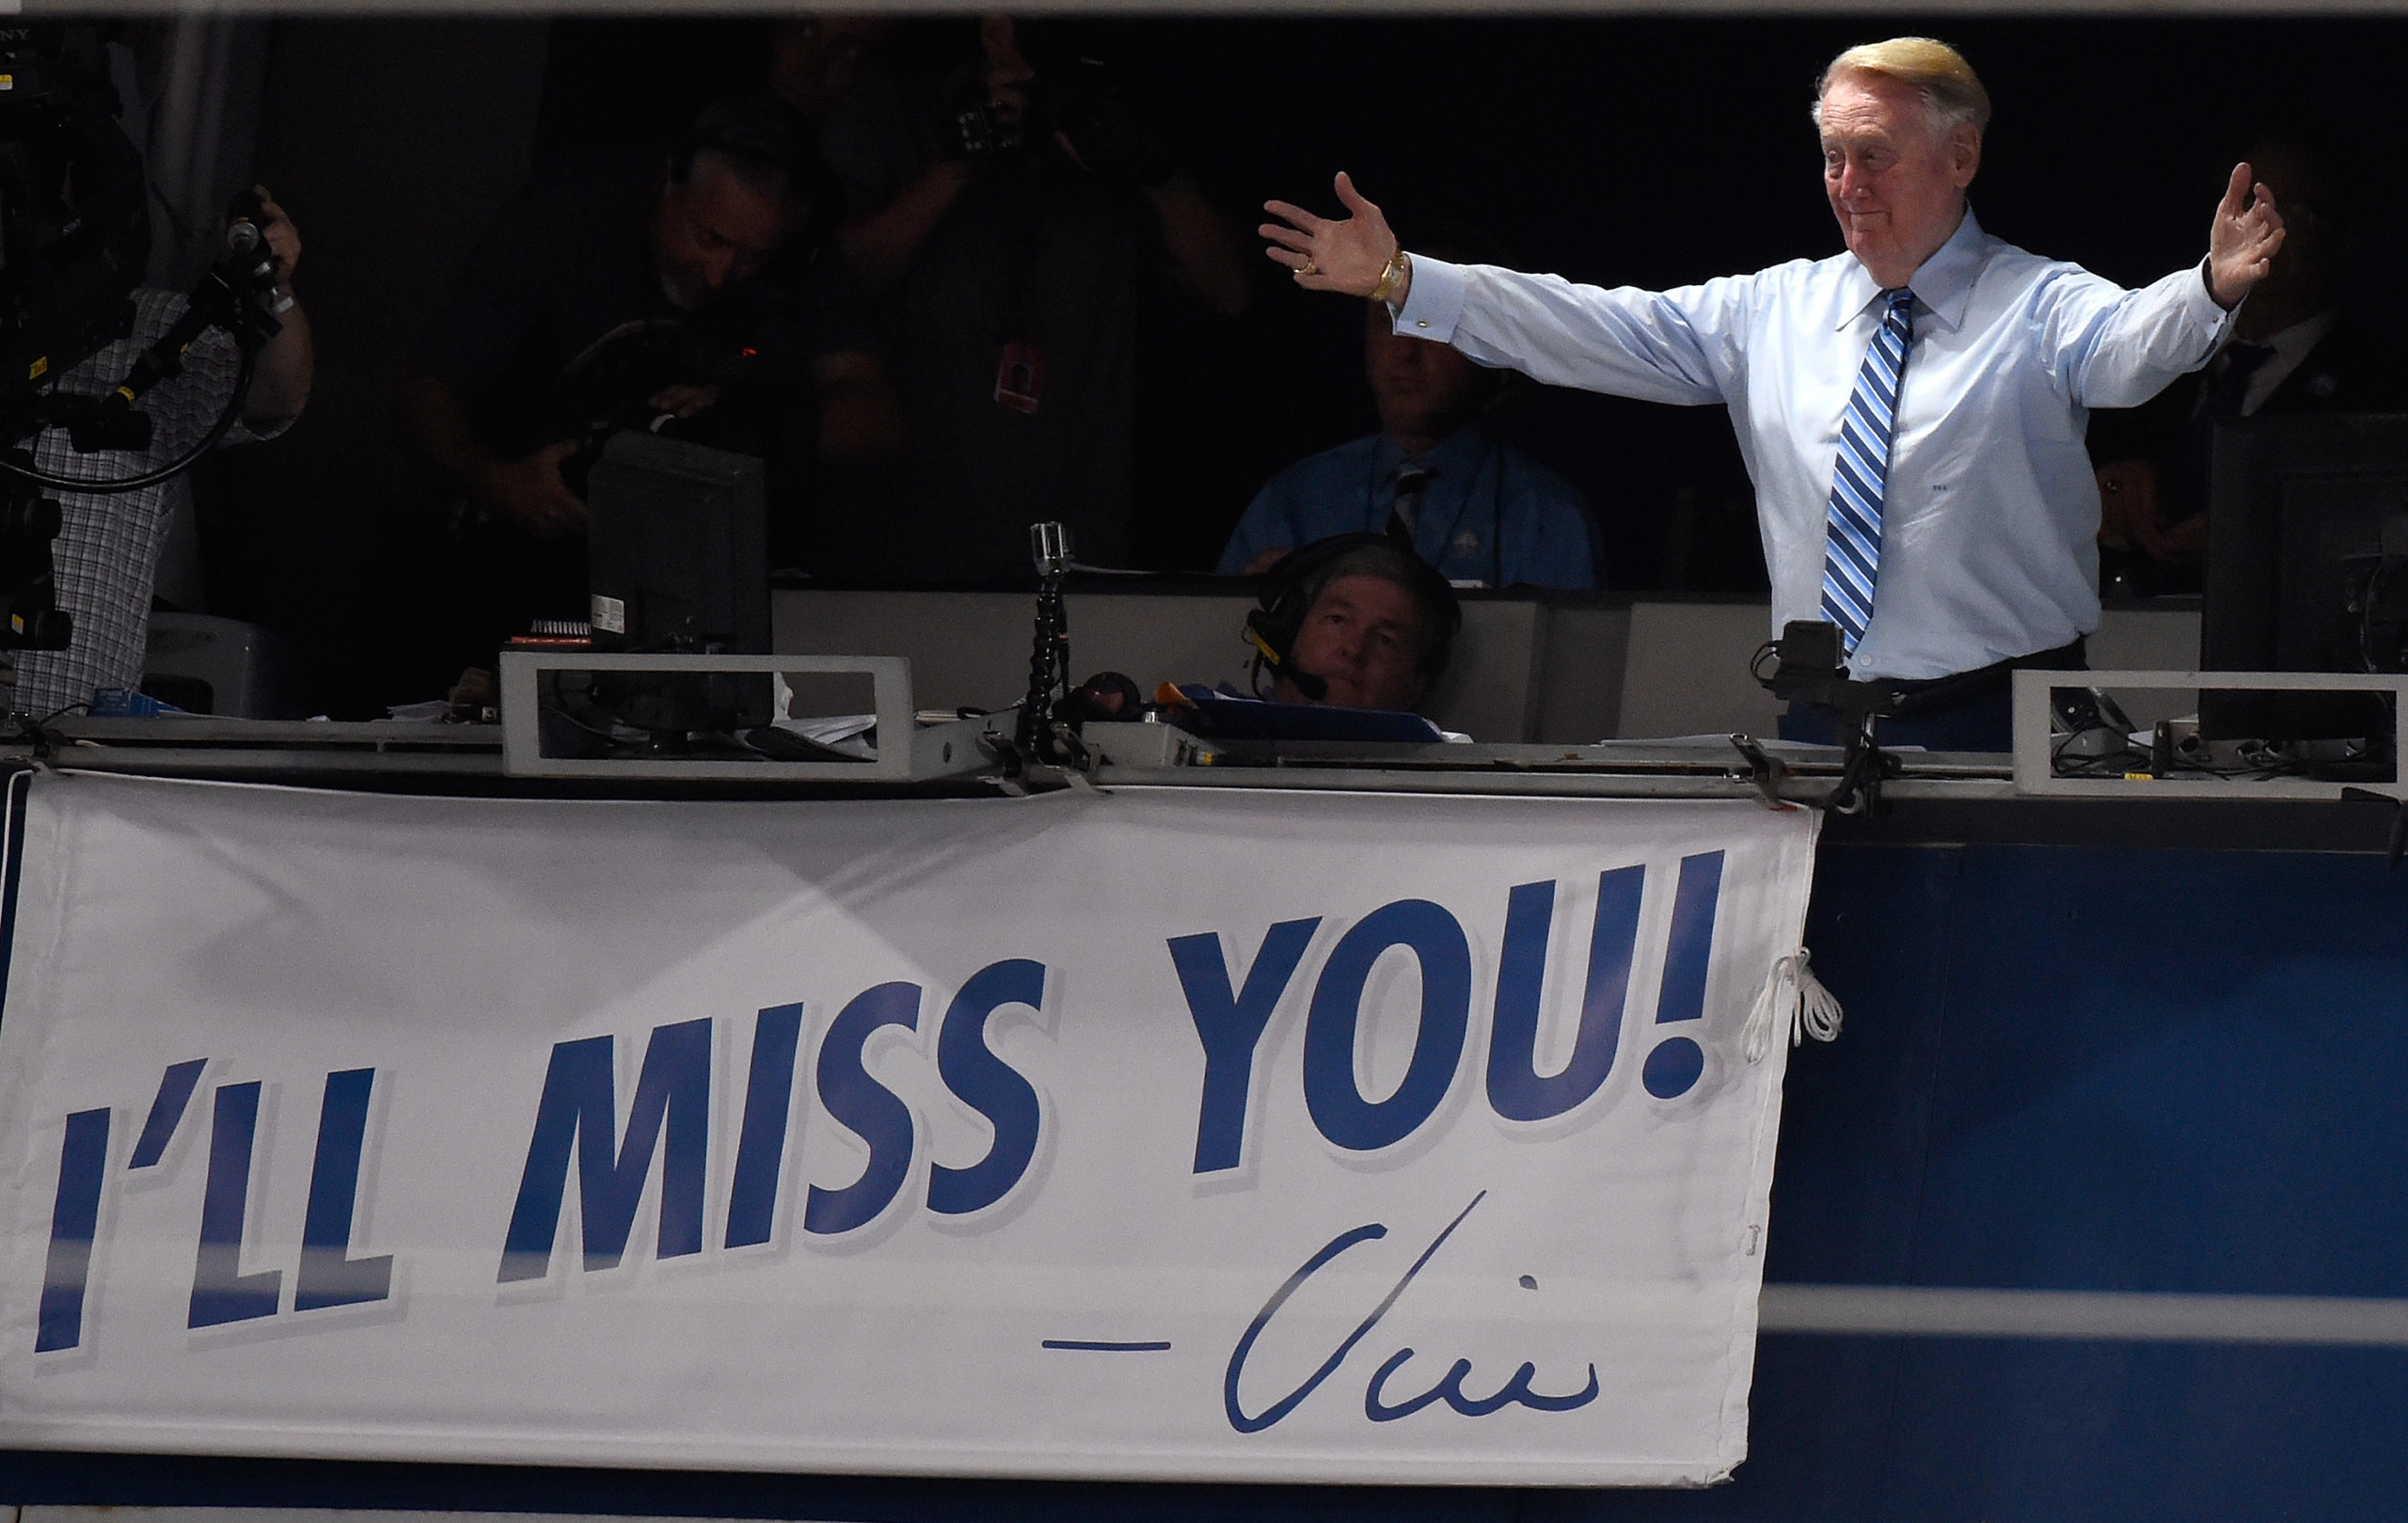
[12,185,313,718]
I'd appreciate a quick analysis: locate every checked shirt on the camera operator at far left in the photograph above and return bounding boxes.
[9,289,284,718]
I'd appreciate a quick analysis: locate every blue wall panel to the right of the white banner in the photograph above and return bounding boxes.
[1686,846,2408,1518]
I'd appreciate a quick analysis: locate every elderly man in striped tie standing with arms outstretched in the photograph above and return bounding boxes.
[1261,39,2283,750]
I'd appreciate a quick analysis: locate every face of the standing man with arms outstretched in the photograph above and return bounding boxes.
[1823,74,1982,289]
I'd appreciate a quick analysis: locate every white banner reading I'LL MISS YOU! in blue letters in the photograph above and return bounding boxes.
[0,773,1814,1484]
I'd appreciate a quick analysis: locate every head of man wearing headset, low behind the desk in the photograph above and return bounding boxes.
[1245,535,1462,713]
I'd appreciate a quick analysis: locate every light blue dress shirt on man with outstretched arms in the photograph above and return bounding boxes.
[1397,210,2230,679]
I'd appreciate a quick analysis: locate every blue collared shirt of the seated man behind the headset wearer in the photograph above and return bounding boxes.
[1221,424,1599,588]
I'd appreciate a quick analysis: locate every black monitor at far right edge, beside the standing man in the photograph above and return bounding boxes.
[2198,412,2408,739]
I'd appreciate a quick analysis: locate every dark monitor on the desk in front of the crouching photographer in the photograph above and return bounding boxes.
[585,429,768,656]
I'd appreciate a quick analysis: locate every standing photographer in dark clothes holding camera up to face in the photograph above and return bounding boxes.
[821,14,1252,583]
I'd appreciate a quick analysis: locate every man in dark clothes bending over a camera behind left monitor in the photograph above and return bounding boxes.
[400,96,900,682]
